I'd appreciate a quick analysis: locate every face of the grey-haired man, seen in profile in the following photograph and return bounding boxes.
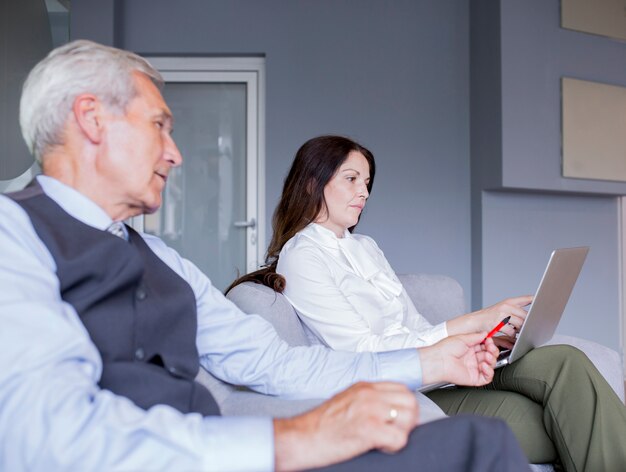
[97,73,182,219]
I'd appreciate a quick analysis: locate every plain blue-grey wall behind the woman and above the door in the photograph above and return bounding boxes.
[72,0,470,293]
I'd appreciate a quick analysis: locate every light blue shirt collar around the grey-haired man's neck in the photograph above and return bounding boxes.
[36,175,113,230]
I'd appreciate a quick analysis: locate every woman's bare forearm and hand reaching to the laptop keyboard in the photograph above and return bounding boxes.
[446,295,533,338]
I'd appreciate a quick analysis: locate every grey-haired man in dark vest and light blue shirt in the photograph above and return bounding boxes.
[0,41,528,471]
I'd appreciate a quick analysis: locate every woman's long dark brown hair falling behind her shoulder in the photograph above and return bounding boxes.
[226,136,376,293]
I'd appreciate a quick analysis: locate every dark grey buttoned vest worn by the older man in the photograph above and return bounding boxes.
[7,181,219,415]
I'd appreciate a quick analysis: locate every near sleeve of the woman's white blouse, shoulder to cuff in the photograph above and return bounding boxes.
[277,245,448,352]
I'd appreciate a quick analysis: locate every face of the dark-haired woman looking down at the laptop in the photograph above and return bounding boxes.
[315,151,370,238]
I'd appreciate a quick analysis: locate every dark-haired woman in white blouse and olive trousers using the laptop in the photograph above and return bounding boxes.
[229,136,626,470]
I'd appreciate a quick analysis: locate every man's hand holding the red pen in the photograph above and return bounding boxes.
[419,331,498,386]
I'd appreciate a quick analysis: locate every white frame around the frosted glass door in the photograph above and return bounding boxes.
[132,56,266,272]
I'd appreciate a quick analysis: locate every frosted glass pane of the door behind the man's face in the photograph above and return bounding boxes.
[144,82,247,290]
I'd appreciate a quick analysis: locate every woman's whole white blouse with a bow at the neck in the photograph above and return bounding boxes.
[276,223,448,351]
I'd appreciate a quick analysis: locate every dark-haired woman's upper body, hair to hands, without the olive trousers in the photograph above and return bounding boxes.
[227,136,532,351]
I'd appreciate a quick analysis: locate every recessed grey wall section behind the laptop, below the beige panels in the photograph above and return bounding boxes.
[482,192,621,352]
